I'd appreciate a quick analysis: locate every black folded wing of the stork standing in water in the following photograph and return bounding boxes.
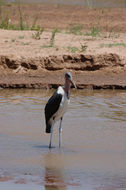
[45,92,62,133]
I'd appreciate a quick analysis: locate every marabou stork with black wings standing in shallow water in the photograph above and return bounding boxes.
[45,72,76,148]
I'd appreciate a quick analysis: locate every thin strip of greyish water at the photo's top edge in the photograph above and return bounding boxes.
[6,0,126,8]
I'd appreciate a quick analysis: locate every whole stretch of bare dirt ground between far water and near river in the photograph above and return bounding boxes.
[0,4,126,89]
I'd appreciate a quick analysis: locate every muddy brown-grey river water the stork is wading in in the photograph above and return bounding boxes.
[0,89,126,190]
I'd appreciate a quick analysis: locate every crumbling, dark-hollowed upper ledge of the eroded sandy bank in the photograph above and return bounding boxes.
[0,53,126,71]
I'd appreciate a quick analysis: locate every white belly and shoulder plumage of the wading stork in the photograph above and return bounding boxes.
[55,87,70,121]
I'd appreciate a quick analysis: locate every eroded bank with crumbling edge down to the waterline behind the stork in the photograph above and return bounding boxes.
[0,53,126,89]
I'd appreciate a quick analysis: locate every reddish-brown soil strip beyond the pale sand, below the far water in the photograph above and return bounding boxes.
[2,3,126,33]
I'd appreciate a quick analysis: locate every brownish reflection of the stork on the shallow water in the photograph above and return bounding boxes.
[44,152,67,190]
